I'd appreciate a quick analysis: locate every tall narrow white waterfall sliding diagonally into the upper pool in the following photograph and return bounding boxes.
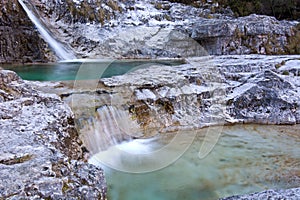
[18,0,76,60]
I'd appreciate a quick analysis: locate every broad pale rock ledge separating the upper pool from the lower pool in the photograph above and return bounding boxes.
[55,55,300,137]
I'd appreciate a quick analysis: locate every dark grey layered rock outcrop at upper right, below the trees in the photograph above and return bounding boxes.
[189,15,296,55]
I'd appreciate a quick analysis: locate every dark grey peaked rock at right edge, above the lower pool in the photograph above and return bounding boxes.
[227,71,300,124]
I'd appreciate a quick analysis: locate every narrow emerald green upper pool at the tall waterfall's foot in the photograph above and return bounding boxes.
[2,60,184,81]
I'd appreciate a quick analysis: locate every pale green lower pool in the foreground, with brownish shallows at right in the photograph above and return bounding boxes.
[90,125,300,200]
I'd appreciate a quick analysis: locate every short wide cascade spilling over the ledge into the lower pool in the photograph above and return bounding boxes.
[80,106,141,155]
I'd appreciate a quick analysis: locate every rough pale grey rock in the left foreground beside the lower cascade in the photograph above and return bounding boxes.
[0,70,106,199]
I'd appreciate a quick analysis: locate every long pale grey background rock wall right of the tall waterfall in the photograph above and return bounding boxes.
[25,0,299,58]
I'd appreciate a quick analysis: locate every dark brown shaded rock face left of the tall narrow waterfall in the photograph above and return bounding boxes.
[0,0,51,63]
